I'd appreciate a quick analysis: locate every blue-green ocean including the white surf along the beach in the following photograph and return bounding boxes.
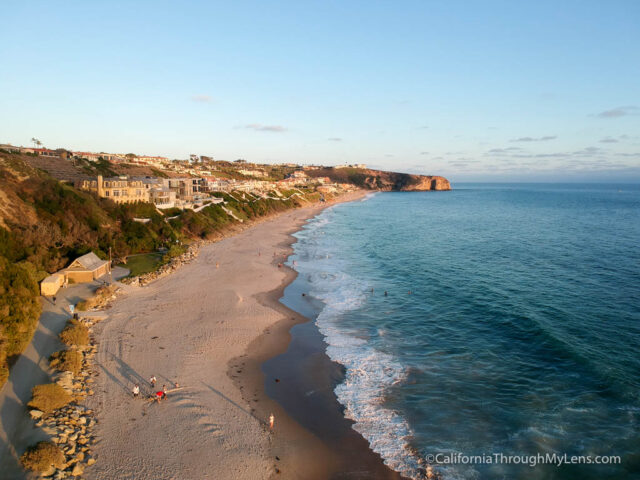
[289,184,640,479]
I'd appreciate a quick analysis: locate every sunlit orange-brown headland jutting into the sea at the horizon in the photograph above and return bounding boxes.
[306,167,451,192]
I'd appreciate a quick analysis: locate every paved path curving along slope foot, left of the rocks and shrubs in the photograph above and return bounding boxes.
[0,267,128,480]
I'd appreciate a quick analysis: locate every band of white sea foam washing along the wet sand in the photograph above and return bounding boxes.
[296,211,419,478]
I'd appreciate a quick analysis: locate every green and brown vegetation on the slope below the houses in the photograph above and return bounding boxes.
[0,152,318,386]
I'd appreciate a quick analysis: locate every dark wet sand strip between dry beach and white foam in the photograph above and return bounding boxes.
[228,190,403,479]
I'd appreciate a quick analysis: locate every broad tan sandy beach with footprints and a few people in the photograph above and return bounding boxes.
[85,192,397,479]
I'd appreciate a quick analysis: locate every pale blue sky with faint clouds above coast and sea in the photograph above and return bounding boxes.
[0,0,640,182]
